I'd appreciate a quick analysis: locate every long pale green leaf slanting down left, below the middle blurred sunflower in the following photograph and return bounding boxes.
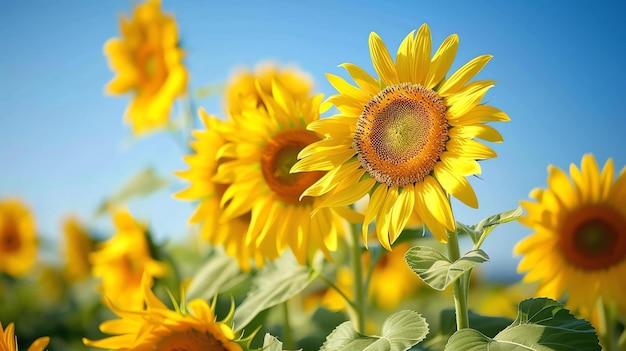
[233,256,318,332]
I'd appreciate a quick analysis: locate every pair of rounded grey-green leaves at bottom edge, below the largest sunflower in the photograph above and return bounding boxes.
[320,311,428,351]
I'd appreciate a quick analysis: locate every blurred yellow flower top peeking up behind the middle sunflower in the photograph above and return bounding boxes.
[225,62,313,115]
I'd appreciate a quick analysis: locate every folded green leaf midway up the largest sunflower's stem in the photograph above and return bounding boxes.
[404,246,489,290]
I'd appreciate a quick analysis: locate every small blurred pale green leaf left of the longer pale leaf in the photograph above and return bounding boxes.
[187,255,241,301]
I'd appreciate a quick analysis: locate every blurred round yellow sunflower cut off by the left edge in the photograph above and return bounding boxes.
[0,199,37,278]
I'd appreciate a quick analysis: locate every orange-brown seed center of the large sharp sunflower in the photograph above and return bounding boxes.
[354,83,448,186]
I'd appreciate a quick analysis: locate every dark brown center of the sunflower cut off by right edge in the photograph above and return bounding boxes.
[559,204,626,270]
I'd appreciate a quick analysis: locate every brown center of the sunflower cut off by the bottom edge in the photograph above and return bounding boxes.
[154,329,228,351]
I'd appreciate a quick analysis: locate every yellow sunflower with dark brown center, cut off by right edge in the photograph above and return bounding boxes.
[514,154,626,328]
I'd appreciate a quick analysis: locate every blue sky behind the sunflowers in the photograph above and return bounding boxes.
[0,0,626,280]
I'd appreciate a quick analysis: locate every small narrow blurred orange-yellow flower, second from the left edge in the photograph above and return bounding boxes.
[63,217,94,281]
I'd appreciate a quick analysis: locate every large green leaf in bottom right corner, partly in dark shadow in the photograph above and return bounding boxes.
[444,298,601,351]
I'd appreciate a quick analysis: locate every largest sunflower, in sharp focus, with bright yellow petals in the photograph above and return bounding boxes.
[292,24,509,250]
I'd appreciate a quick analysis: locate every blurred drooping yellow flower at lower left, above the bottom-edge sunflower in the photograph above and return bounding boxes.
[90,210,167,308]
